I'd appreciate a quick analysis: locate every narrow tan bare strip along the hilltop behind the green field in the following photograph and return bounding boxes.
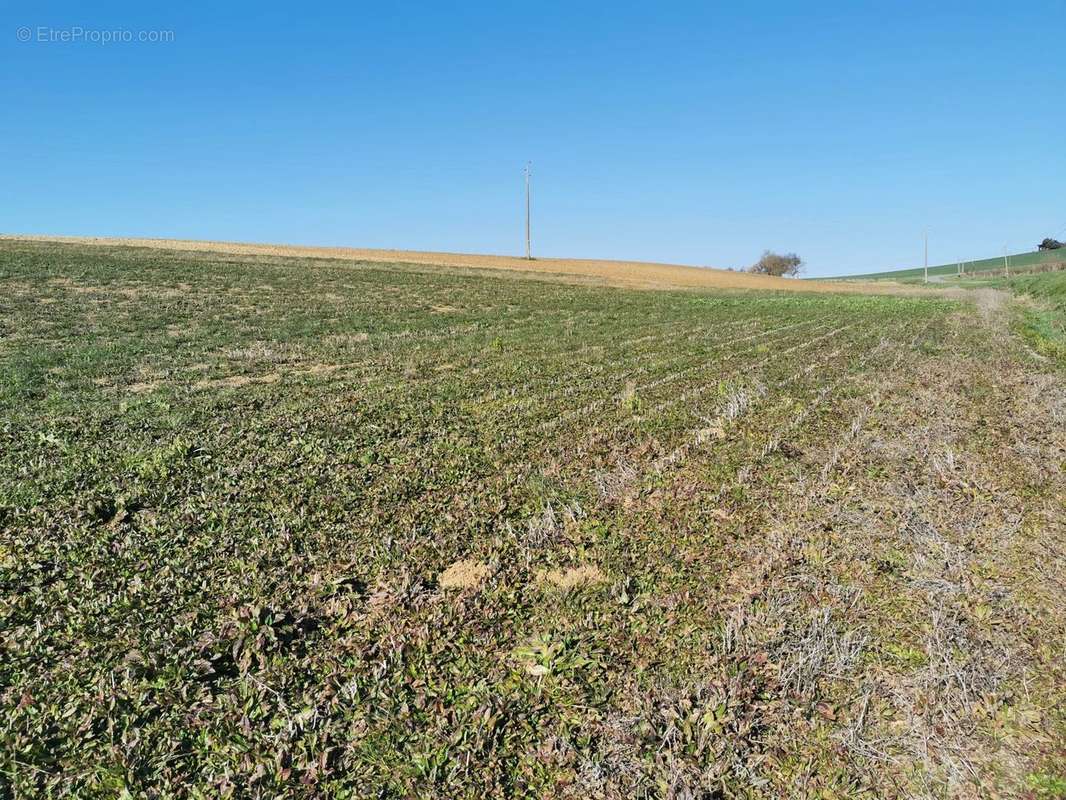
[0,234,924,294]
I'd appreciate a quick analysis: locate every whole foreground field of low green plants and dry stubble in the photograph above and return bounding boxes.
[0,241,1066,798]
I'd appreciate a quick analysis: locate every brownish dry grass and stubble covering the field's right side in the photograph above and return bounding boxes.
[562,299,1066,798]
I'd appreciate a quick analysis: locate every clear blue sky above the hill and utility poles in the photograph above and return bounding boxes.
[0,0,1066,274]
